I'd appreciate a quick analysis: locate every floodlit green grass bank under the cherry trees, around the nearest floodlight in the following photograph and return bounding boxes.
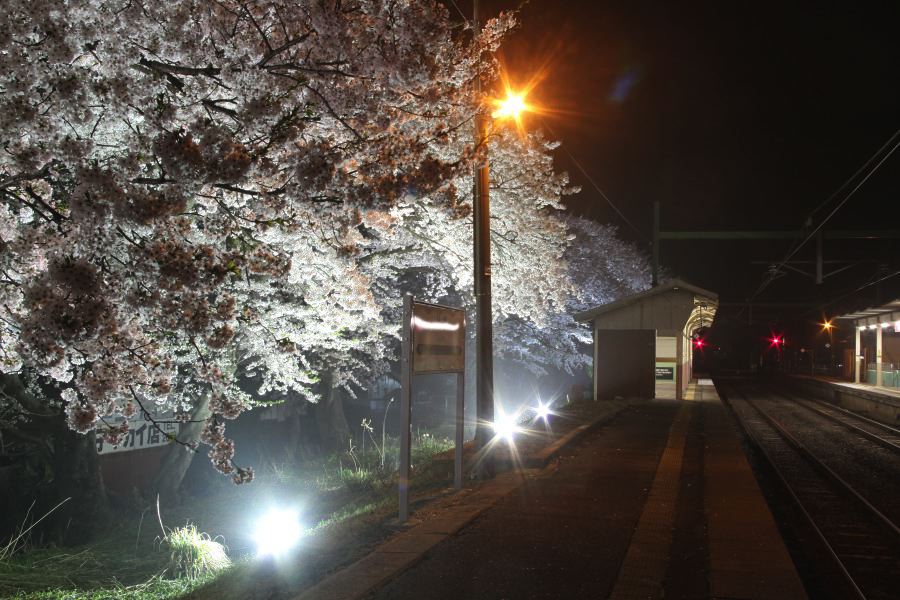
[0,432,452,600]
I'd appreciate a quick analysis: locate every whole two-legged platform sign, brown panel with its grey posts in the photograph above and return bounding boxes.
[400,295,466,522]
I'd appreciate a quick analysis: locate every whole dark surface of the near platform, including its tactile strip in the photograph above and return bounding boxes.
[300,386,806,600]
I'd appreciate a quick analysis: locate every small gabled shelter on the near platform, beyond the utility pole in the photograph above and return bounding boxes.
[574,279,719,400]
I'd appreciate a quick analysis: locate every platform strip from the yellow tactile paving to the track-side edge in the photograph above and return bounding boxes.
[608,380,806,600]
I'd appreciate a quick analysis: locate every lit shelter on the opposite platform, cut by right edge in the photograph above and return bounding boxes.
[837,299,900,390]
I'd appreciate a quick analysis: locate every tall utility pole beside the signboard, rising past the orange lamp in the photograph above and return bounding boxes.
[472,0,494,479]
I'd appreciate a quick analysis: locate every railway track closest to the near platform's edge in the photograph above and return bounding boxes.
[722,386,900,600]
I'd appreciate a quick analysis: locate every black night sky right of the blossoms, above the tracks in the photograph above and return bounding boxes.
[448,0,900,318]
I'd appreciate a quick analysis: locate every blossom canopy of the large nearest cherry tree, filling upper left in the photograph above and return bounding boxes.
[0,0,512,482]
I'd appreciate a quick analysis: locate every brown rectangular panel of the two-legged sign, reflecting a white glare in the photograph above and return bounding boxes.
[410,302,466,375]
